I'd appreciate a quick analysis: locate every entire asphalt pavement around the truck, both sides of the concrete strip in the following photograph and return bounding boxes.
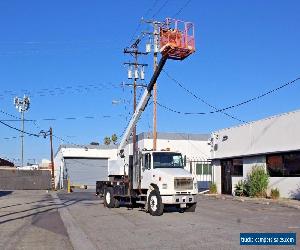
[0,191,300,250]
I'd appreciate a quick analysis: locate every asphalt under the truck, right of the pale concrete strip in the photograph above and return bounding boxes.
[59,192,300,249]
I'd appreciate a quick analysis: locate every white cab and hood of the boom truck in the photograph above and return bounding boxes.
[133,151,198,216]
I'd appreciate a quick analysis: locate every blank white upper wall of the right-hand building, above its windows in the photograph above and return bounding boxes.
[212,110,300,158]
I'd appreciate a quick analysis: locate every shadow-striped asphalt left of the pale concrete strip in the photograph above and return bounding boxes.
[0,191,73,250]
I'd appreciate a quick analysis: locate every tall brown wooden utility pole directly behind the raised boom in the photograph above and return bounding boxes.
[143,20,161,151]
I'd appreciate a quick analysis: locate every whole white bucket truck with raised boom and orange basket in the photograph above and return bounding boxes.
[96,19,198,216]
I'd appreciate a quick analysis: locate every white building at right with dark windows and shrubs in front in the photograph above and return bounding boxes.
[211,110,300,198]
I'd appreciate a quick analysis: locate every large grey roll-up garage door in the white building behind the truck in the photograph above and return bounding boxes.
[64,158,108,187]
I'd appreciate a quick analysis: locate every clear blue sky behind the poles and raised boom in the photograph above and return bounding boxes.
[0,0,300,164]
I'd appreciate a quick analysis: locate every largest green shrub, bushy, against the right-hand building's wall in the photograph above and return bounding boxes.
[247,166,269,197]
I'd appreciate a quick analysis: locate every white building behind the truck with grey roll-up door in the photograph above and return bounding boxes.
[54,133,211,188]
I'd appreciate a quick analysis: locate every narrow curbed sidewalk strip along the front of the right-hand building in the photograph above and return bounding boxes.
[202,194,300,210]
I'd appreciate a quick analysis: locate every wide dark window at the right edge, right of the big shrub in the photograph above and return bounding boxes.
[267,152,300,177]
